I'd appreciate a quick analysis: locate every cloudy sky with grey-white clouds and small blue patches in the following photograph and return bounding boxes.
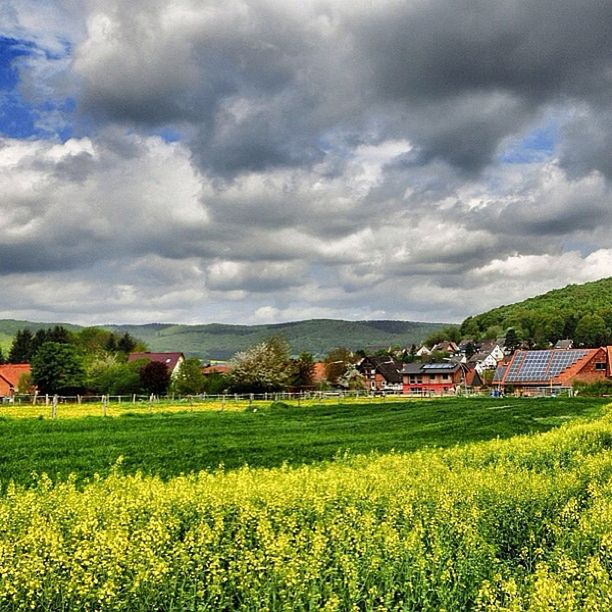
[0,0,612,324]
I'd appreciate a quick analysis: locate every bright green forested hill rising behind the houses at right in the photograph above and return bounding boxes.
[461,277,612,345]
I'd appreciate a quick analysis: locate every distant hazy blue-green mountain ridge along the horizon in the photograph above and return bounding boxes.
[0,319,448,359]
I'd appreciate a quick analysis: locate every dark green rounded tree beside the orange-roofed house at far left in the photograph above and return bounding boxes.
[32,342,85,395]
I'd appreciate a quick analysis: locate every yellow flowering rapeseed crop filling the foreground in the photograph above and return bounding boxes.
[0,404,612,611]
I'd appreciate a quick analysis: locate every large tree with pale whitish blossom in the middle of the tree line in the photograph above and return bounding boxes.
[229,337,291,393]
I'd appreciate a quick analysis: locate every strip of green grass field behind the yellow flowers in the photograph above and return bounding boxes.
[0,398,603,487]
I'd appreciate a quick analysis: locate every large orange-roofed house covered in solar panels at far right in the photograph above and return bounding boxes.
[493,347,612,395]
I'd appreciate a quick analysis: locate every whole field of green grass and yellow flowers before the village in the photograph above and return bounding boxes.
[0,400,612,612]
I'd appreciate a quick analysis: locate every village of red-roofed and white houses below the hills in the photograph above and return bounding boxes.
[0,338,612,402]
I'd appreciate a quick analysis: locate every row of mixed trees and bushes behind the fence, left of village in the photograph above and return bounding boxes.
[0,326,362,396]
